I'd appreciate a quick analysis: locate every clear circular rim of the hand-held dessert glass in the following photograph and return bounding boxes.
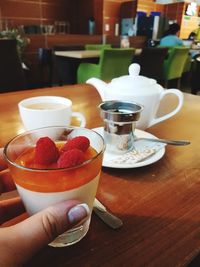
[3,126,106,173]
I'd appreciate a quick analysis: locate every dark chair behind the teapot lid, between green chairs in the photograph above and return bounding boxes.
[133,47,168,81]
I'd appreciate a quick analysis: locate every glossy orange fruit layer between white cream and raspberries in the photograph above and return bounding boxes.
[9,147,103,192]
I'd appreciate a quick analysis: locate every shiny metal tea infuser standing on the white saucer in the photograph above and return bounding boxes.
[99,100,143,154]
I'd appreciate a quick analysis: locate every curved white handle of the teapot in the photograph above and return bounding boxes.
[148,89,184,127]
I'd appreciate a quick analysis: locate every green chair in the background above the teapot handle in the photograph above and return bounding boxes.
[162,46,189,88]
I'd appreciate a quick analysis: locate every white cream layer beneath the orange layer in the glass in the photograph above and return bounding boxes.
[16,173,100,215]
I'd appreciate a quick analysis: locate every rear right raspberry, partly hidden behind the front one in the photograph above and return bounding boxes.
[61,136,90,152]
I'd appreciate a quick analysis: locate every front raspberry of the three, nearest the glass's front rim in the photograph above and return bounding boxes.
[57,148,85,168]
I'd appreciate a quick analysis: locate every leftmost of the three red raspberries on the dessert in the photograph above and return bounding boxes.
[35,137,59,165]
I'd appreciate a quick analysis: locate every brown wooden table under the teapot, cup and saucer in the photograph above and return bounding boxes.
[0,85,200,267]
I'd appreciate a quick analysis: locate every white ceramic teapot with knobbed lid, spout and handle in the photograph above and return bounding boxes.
[87,63,183,130]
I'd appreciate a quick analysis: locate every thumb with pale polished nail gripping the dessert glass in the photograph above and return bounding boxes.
[0,200,90,263]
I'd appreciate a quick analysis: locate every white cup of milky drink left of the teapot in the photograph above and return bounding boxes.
[18,96,86,130]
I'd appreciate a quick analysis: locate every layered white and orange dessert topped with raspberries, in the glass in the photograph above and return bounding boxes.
[9,136,103,215]
